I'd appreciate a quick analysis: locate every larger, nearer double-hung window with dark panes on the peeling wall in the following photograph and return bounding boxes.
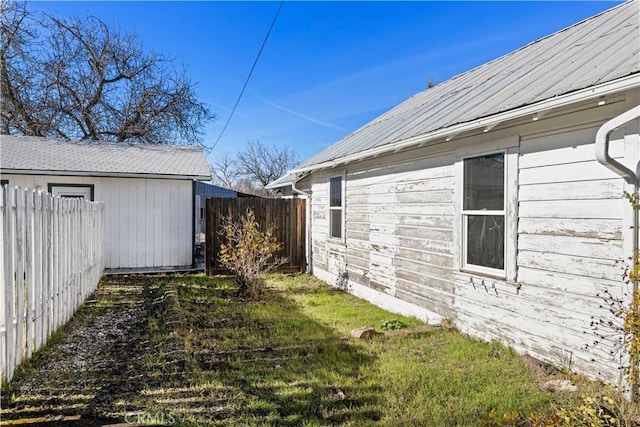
[462,153,505,276]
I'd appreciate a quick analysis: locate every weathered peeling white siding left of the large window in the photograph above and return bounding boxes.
[303,147,455,321]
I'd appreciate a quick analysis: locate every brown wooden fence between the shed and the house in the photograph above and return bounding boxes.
[205,197,306,275]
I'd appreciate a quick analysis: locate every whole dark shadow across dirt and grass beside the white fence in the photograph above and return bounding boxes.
[2,275,381,426]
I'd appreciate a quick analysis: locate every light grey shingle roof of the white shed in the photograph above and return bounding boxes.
[0,135,211,179]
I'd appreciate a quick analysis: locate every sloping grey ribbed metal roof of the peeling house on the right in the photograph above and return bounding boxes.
[295,0,640,172]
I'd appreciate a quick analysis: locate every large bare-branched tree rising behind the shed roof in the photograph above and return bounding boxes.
[0,2,215,144]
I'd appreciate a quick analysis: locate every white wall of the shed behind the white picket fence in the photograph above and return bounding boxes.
[2,174,193,269]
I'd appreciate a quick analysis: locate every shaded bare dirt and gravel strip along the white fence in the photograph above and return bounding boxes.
[1,276,181,425]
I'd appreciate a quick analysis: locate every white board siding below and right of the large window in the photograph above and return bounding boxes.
[456,127,624,381]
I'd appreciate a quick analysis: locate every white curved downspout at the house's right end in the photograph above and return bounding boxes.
[596,105,640,399]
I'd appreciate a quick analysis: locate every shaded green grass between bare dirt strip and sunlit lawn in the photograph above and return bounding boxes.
[157,283,381,425]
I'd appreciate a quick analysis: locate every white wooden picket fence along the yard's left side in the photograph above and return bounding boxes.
[0,185,104,380]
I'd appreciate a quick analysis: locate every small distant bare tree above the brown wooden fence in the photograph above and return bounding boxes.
[236,140,298,187]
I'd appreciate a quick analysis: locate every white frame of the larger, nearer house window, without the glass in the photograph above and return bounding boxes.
[460,149,510,279]
